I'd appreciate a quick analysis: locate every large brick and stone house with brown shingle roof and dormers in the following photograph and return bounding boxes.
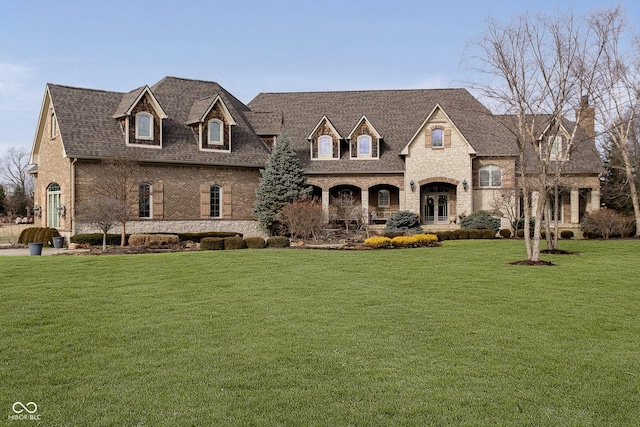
[31,77,602,236]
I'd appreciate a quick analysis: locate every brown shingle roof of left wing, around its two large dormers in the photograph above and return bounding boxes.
[48,77,268,167]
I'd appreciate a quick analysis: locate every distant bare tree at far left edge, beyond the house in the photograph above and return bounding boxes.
[0,148,33,219]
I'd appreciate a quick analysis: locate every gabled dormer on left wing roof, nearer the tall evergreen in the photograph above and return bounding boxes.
[187,95,236,152]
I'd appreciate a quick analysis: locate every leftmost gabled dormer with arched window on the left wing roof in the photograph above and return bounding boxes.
[113,86,167,148]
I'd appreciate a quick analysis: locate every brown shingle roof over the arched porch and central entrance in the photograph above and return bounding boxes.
[248,89,517,173]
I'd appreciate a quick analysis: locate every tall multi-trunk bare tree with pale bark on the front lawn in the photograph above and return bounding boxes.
[475,8,621,262]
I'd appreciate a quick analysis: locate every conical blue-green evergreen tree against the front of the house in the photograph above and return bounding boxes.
[252,131,311,232]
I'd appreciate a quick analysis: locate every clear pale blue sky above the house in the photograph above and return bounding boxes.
[0,0,640,156]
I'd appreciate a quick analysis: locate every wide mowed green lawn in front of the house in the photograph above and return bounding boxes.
[0,240,640,426]
